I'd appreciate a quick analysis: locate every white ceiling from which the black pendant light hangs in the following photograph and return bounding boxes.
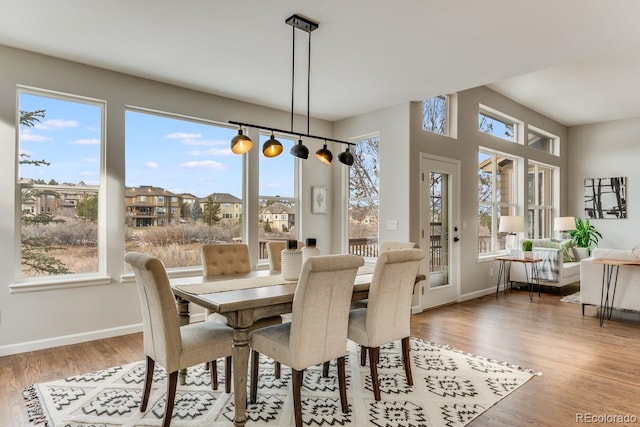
[0,0,640,126]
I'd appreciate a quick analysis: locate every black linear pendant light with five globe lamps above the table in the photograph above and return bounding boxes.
[229,15,355,166]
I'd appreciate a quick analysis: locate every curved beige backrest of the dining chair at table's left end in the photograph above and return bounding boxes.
[124,252,182,372]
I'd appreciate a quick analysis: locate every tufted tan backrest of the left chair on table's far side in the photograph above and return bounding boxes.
[201,243,251,276]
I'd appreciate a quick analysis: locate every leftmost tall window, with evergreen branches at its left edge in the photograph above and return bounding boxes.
[18,89,105,278]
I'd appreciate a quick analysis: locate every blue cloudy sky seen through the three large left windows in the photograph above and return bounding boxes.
[20,92,295,198]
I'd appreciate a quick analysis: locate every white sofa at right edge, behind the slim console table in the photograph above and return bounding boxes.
[580,248,640,315]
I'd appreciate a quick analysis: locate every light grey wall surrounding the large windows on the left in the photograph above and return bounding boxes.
[0,46,344,355]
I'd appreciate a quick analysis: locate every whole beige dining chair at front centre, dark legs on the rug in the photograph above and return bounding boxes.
[249,255,364,427]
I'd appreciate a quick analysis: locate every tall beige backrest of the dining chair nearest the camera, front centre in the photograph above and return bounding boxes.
[289,255,364,370]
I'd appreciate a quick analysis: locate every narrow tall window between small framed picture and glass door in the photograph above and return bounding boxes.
[348,136,380,257]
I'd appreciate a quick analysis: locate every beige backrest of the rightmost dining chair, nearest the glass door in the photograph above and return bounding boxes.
[365,249,426,347]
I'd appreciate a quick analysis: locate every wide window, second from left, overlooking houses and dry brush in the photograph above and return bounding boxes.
[125,108,243,271]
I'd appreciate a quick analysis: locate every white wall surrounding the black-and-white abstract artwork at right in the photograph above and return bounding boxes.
[567,118,640,249]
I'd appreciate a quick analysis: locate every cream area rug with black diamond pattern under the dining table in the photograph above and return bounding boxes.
[24,338,541,427]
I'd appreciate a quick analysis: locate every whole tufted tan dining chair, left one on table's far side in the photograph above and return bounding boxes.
[200,243,282,380]
